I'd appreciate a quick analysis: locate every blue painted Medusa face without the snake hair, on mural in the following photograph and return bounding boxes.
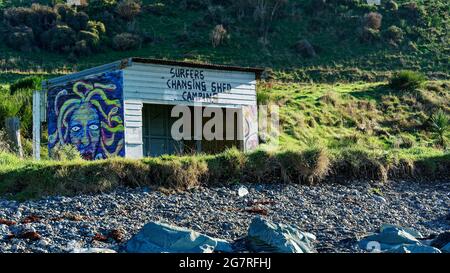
[68,103,100,159]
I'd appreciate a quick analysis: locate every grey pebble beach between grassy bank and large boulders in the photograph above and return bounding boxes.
[0,181,450,252]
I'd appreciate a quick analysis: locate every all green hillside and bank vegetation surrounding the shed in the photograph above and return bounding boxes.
[0,0,450,198]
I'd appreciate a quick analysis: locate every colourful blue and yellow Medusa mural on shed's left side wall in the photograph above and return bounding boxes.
[47,71,125,160]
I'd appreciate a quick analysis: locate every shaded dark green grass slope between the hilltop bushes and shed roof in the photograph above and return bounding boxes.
[0,0,450,82]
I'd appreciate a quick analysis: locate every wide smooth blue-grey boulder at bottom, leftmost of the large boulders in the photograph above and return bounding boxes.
[126,222,233,253]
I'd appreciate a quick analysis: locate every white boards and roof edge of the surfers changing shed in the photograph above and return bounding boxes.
[41,57,263,158]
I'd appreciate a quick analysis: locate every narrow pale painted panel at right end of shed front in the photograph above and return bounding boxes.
[242,105,259,151]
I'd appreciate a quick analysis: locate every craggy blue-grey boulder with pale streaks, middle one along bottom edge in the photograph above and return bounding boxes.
[247,217,316,253]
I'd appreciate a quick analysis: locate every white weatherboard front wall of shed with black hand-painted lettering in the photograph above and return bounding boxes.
[123,63,258,158]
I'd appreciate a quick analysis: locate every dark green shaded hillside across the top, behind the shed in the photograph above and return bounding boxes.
[0,0,450,82]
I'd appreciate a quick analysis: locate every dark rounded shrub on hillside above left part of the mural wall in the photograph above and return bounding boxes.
[41,25,76,52]
